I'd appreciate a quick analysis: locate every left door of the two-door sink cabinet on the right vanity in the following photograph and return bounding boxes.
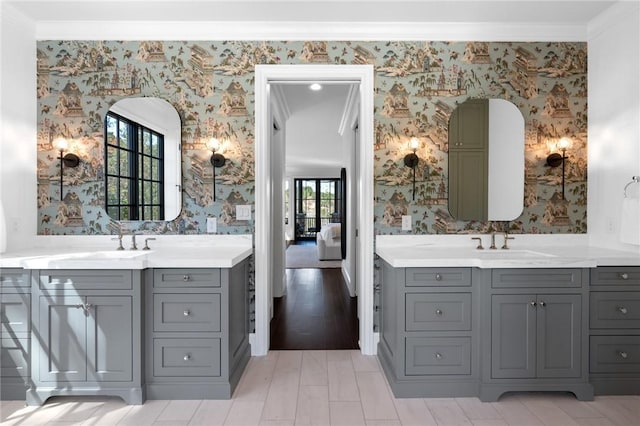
[491,294,536,379]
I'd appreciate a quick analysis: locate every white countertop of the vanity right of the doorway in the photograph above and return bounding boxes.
[376,234,640,268]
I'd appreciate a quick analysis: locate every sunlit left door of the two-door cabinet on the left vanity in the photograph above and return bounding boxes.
[38,296,87,383]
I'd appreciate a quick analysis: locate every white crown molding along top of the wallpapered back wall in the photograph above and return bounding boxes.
[36,20,587,41]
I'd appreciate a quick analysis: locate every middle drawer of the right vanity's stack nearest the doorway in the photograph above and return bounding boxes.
[405,293,471,331]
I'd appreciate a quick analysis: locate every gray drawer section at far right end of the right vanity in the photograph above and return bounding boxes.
[589,266,640,395]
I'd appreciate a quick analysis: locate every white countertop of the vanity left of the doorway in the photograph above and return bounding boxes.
[0,235,253,269]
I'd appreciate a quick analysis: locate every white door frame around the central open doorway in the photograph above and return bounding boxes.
[251,64,376,356]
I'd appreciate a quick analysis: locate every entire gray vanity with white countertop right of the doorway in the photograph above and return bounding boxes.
[377,237,640,401]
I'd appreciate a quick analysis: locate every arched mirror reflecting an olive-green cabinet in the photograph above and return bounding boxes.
[449,99,524,221]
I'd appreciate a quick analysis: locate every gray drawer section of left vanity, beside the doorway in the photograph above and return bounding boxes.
[146,260,250,399]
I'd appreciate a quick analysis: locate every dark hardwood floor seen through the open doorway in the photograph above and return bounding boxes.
[271,268,358,350]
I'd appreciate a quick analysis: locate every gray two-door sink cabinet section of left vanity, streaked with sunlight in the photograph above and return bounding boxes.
[27,270,144,405]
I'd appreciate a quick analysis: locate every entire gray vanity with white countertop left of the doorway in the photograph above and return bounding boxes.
[0,239,252,405]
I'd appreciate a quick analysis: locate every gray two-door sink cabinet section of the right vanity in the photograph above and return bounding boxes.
[480,269,593,401]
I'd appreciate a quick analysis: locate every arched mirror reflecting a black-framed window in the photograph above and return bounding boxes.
[104,98,182,221]
